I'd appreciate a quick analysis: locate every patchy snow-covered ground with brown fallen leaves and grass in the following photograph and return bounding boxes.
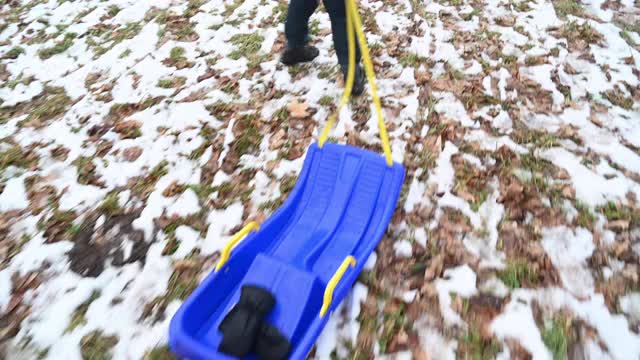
[0,0,640,359]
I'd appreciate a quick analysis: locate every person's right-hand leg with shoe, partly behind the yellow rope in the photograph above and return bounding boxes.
[324,0,366,96]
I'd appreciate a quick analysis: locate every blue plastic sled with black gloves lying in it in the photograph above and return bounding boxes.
[169,143,404,360]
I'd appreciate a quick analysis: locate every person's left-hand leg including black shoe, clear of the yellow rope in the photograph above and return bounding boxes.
[281,0,319,65]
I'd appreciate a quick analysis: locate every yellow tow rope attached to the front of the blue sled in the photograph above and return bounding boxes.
[318,0,393,166]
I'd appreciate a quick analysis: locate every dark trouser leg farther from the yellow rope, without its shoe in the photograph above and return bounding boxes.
[284,0,318,48]
